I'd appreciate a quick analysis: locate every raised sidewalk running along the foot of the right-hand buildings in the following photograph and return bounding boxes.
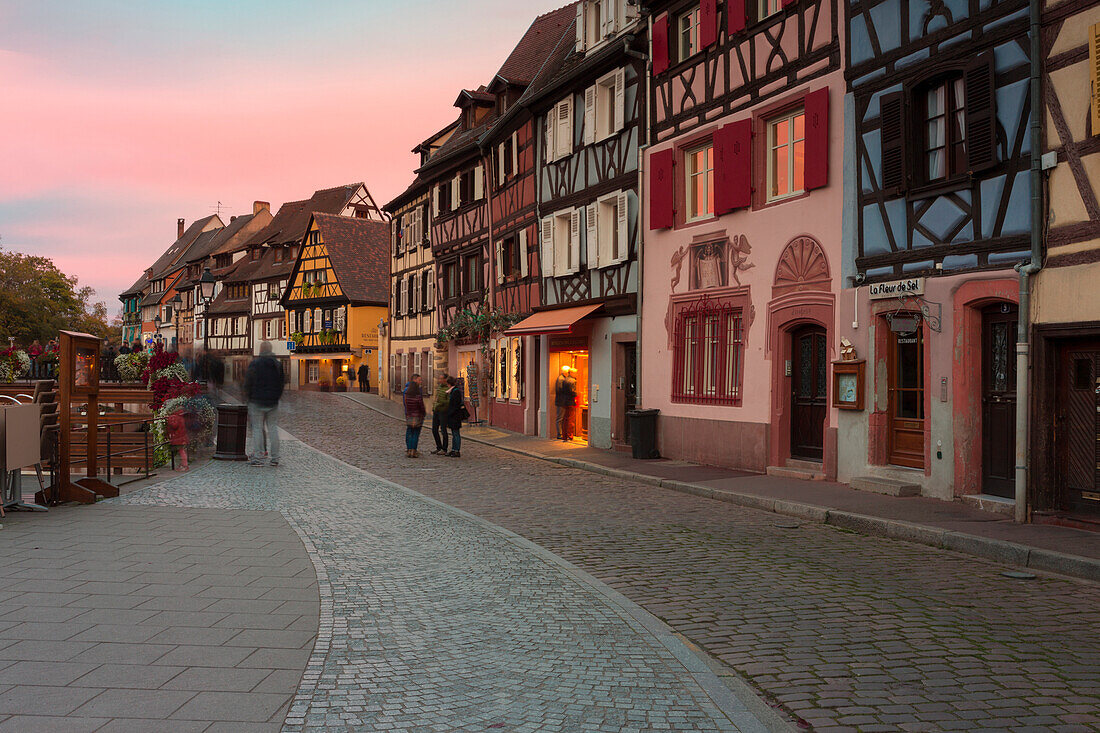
[344,393,1100,580]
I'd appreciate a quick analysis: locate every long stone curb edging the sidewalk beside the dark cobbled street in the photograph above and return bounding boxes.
[336,397,1100,582]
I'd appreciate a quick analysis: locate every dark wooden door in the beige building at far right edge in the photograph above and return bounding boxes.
[1055,342,1100,512]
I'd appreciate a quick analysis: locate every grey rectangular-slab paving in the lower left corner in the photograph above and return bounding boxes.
[0,503,319,733]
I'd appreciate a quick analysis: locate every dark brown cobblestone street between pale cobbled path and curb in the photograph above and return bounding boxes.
[283,393,1100,731]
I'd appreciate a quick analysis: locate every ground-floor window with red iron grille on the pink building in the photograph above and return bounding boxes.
[672,300,745,405]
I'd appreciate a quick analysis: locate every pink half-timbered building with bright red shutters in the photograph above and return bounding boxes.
[640,0,844,477]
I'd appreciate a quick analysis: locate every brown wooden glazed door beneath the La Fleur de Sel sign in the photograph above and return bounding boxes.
[887,315,925,469]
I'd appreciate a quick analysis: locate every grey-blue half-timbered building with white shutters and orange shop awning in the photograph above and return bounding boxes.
[496,0,647,448]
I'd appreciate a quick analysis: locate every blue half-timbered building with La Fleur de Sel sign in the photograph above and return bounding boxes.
[838,0,1033,499]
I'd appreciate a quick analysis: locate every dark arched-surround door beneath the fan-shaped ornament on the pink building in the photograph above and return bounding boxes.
[791,326,828,461]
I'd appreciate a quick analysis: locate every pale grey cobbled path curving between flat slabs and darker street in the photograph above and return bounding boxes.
[111,431,765,733]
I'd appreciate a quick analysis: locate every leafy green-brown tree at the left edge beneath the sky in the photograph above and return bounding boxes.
[0,249,110,344]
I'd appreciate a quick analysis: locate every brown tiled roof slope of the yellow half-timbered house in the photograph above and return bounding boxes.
[312,214,389,306]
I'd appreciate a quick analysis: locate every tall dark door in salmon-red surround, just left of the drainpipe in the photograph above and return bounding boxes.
[981,303,1019,499]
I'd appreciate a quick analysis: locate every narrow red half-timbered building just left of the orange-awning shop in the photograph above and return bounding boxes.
[479,6,574,434]
